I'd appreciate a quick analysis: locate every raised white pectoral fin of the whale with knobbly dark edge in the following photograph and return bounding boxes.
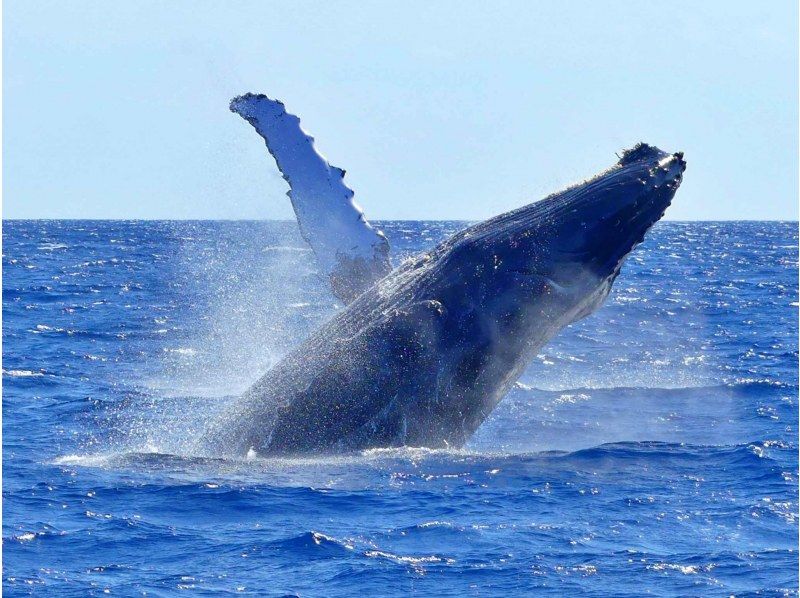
[230,93,391,303]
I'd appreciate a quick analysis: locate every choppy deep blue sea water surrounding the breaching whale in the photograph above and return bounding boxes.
[3,221,798,596]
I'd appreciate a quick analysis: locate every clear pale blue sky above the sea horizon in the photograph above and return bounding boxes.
[3,0,798,220]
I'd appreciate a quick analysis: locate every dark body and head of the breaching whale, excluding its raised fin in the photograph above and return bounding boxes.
[202,144,686,456]
